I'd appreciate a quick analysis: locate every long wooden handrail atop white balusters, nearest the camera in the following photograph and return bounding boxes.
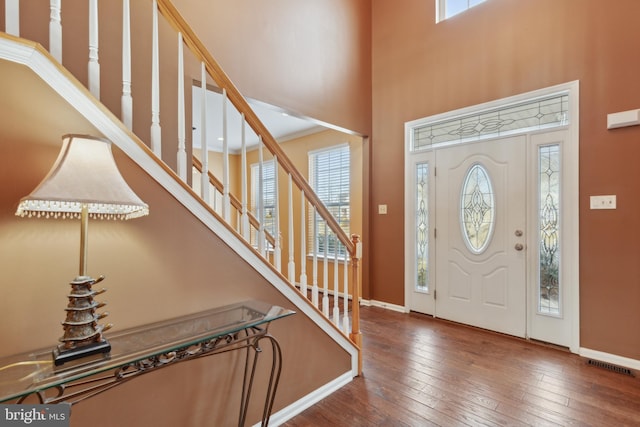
[157,0,356,256]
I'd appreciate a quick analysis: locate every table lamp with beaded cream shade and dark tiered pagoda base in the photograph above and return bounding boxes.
[16,135,149,366]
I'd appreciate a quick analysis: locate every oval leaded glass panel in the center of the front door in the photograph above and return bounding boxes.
[460,163,495,254]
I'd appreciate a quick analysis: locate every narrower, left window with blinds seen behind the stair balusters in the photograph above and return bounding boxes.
[251,160,276,246]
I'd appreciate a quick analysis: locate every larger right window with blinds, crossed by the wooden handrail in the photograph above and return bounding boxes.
[308,144,351,258]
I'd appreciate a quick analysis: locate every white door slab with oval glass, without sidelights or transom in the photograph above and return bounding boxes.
[434,136,526,337]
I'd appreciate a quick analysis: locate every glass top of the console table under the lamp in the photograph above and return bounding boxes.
[0,301,295,402]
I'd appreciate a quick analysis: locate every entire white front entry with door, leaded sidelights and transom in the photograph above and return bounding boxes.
[405,82,580,353]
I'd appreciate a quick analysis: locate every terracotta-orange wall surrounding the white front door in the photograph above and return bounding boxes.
[367,0,640,359]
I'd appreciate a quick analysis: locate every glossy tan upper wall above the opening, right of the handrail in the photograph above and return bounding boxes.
[174,0,371,135]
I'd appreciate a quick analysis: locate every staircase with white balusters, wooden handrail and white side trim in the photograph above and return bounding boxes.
[0,0,362,424]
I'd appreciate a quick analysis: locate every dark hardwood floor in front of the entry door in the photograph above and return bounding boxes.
[284,307,640,427]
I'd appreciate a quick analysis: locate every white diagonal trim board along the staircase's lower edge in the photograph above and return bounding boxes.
[0,36,358,376]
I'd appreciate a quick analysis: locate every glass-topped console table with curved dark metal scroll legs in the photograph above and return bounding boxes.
[0,301,295,426]
